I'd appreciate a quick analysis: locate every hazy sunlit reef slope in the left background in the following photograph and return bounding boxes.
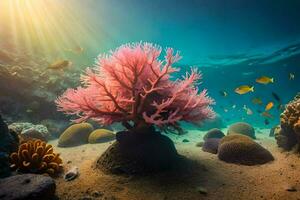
[0,47,81,123]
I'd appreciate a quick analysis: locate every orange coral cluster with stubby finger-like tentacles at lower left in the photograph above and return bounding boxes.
[10,139,62,175]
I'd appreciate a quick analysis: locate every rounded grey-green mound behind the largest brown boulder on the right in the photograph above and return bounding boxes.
[227,122,256,139]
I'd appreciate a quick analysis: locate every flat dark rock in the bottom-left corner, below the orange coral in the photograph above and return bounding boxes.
[0,174,56,200]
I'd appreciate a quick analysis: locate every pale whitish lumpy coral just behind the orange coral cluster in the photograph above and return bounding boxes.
[8,122,51,141]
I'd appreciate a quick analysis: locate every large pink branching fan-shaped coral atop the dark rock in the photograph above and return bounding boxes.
[56,43,214,133]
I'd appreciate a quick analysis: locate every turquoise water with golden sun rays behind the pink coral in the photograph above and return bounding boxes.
[0,0,300,128]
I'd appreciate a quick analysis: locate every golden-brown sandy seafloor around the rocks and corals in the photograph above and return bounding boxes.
[50,129,300,200]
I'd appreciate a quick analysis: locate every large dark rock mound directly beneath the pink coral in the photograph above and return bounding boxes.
[96,129,181,174]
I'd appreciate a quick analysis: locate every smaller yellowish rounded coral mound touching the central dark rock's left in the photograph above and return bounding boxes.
[88,129,116,144]
